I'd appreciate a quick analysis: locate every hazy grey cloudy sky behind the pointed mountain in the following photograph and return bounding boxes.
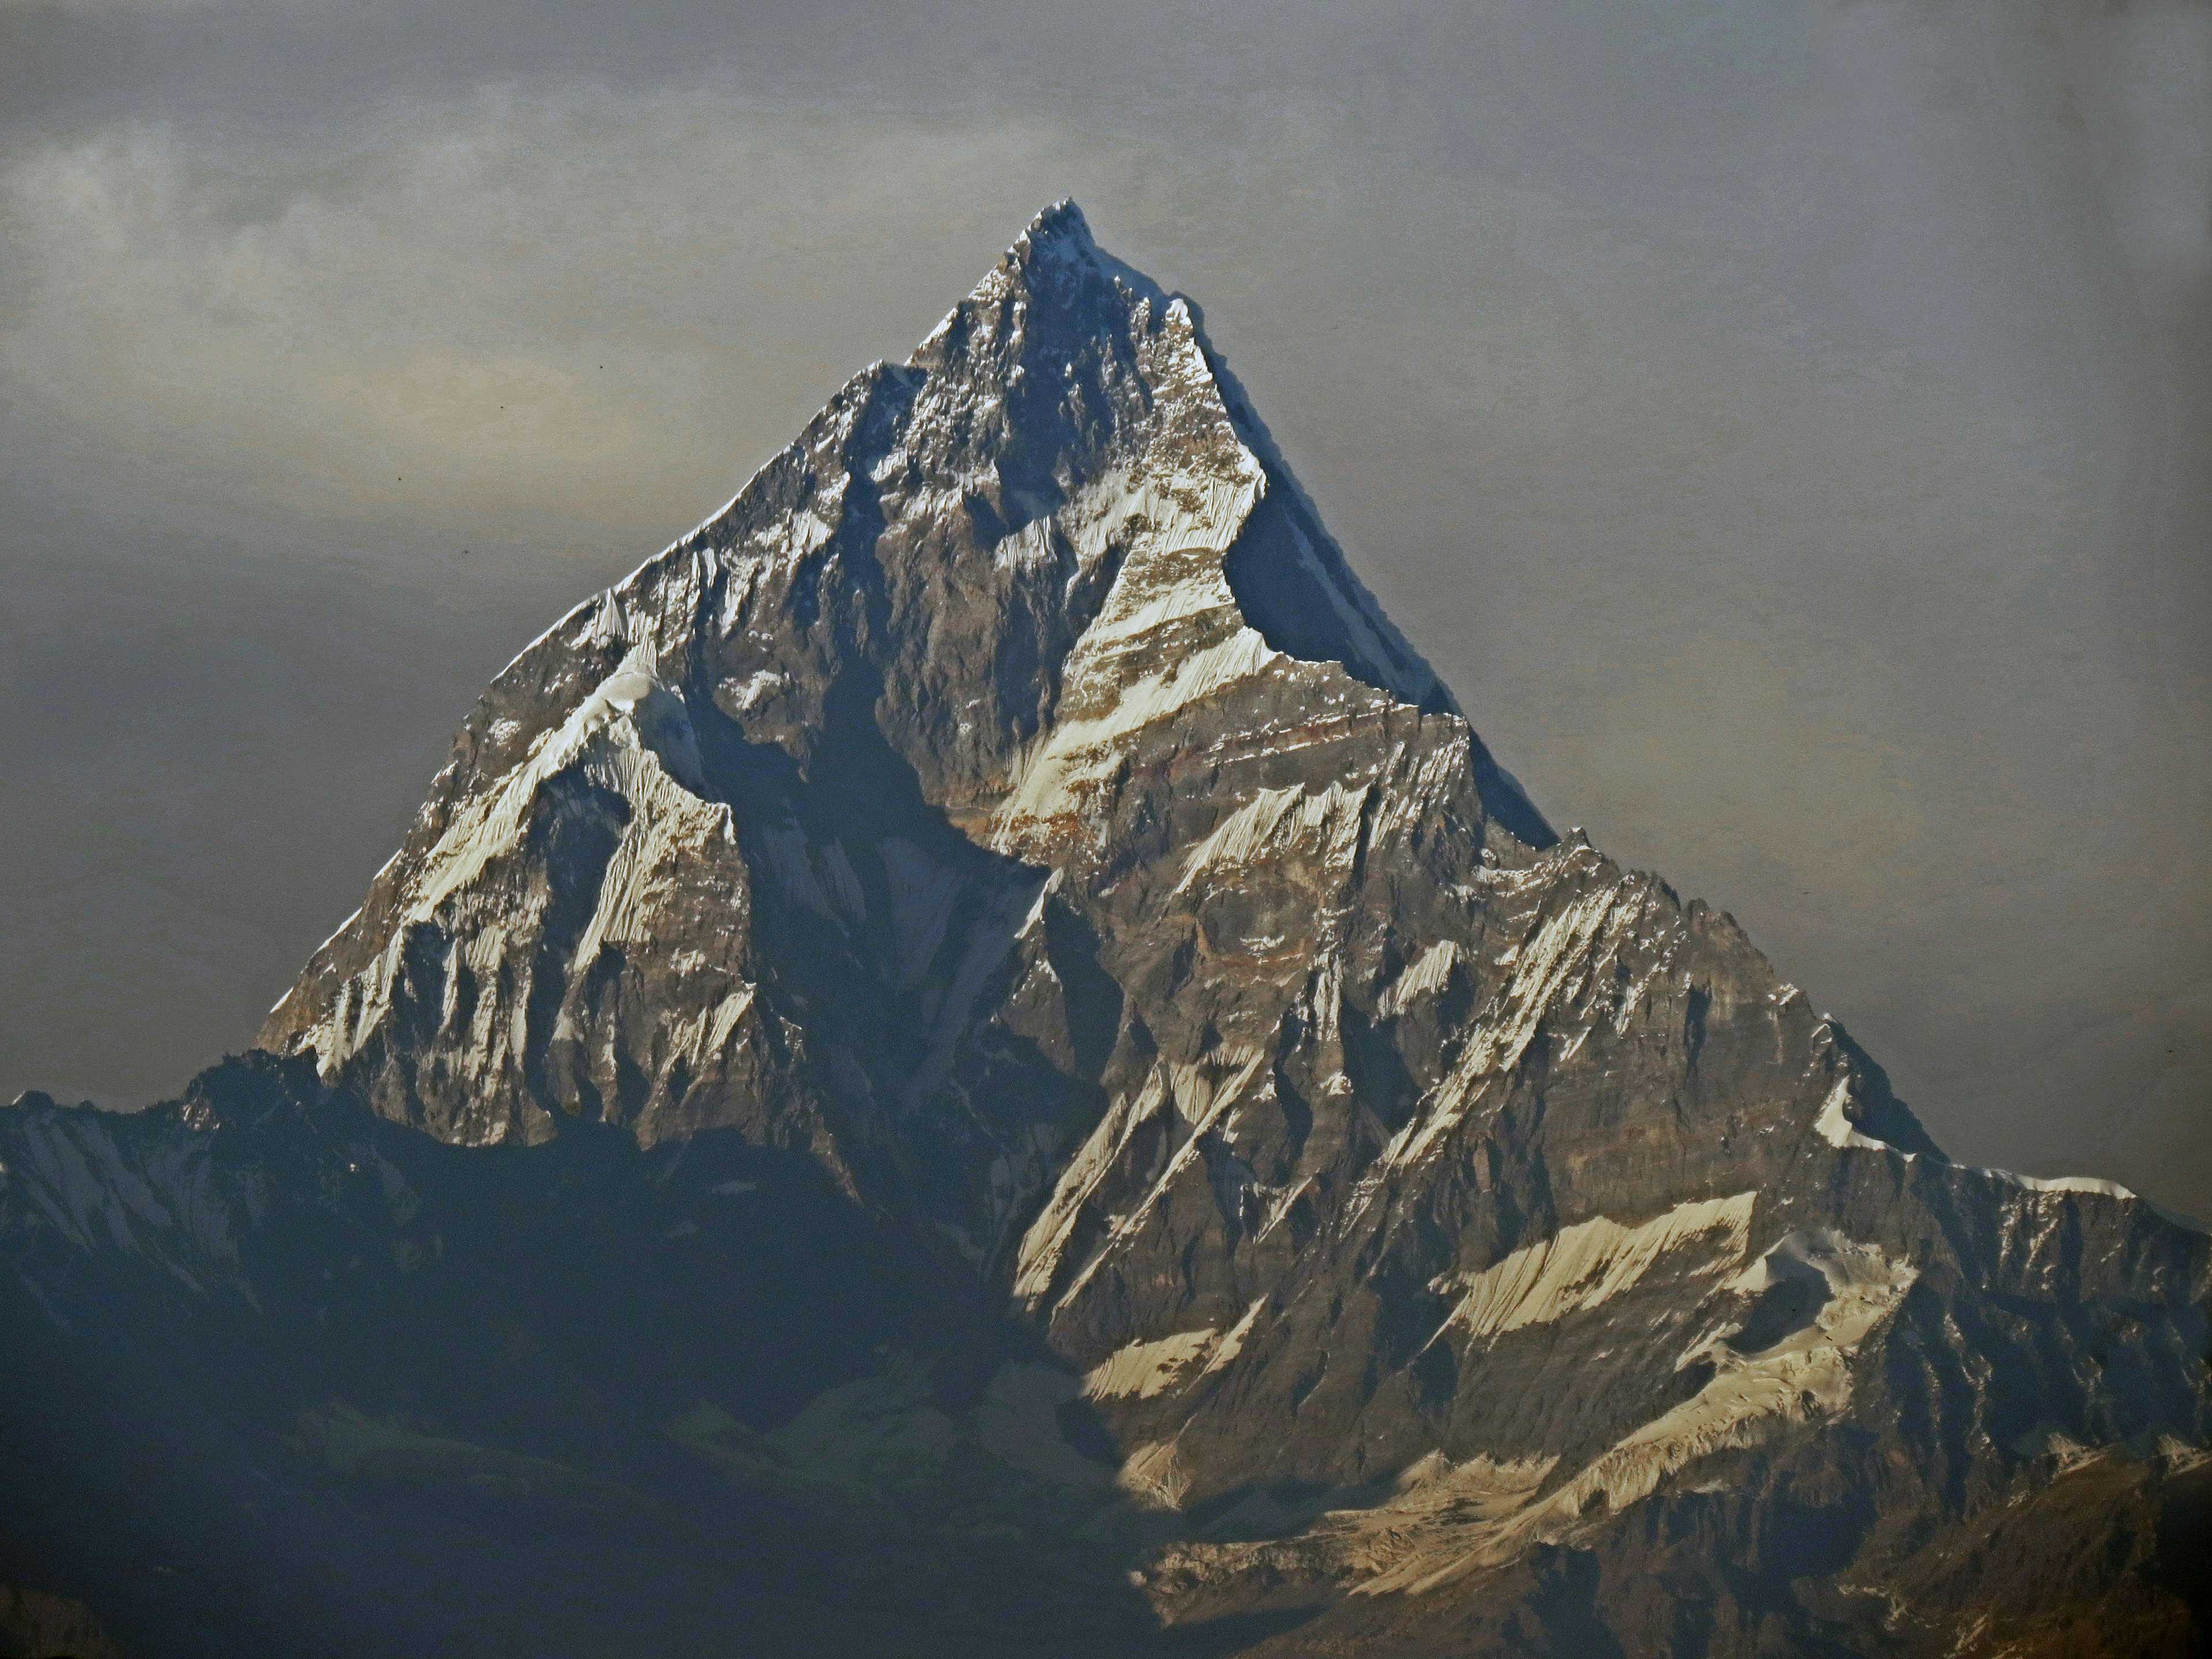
[0,0,2212,1214]
